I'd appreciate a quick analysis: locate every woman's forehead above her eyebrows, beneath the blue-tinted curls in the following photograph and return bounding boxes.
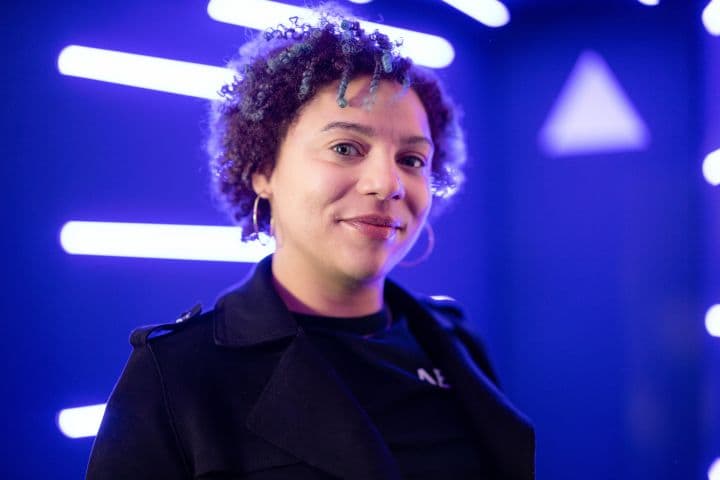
[295,76,430,137]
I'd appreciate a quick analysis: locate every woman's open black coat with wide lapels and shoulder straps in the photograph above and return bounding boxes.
[87,257,535,480]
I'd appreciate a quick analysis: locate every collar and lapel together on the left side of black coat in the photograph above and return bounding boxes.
[214,257,400,480]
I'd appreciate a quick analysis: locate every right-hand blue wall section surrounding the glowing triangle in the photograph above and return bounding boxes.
[480,2,707,479]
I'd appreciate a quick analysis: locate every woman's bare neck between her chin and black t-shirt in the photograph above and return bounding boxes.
[272,253,385,317]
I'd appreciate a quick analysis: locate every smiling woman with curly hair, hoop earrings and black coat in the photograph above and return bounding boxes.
[88,11,534,480]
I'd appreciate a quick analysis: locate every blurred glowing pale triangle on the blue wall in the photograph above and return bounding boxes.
[539,51,650,156]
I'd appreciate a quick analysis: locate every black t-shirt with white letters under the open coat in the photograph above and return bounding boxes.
[295,309,487,479]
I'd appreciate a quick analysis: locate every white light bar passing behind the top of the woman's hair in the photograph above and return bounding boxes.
[207,0,455,68]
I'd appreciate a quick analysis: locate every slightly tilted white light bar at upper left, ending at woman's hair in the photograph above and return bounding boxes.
[58,45,233,100]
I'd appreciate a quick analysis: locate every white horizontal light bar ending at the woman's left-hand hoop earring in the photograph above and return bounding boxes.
[60,221,274,263]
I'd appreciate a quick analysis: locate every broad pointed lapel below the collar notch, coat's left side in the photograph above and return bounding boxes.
[242,332,400,480]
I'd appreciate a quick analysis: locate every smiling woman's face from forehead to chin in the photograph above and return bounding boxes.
[253,77,433,283]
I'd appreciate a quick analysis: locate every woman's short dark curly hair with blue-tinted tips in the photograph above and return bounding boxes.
[206,12,465,240]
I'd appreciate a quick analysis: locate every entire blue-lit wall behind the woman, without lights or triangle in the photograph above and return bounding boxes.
[0,0,720,480]
